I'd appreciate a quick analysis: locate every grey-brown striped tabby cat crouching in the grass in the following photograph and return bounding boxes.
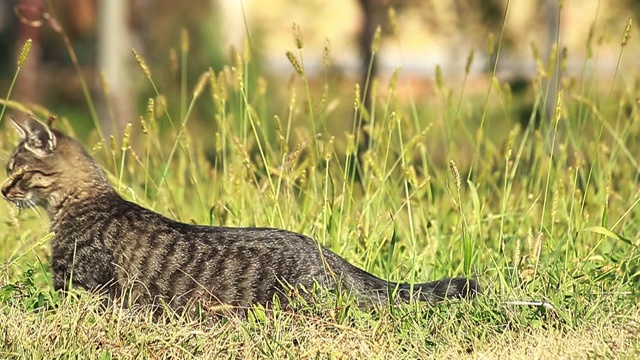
[1,117,480,309]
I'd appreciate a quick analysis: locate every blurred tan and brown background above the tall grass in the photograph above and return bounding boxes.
[0,0,640,145]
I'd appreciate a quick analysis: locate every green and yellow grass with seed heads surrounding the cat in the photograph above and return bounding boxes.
[0,7,640,359]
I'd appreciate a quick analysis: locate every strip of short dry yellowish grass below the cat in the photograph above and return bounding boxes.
[0,296,640,359]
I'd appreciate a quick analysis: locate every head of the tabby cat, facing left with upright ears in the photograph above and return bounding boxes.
[2,117,104,214]
